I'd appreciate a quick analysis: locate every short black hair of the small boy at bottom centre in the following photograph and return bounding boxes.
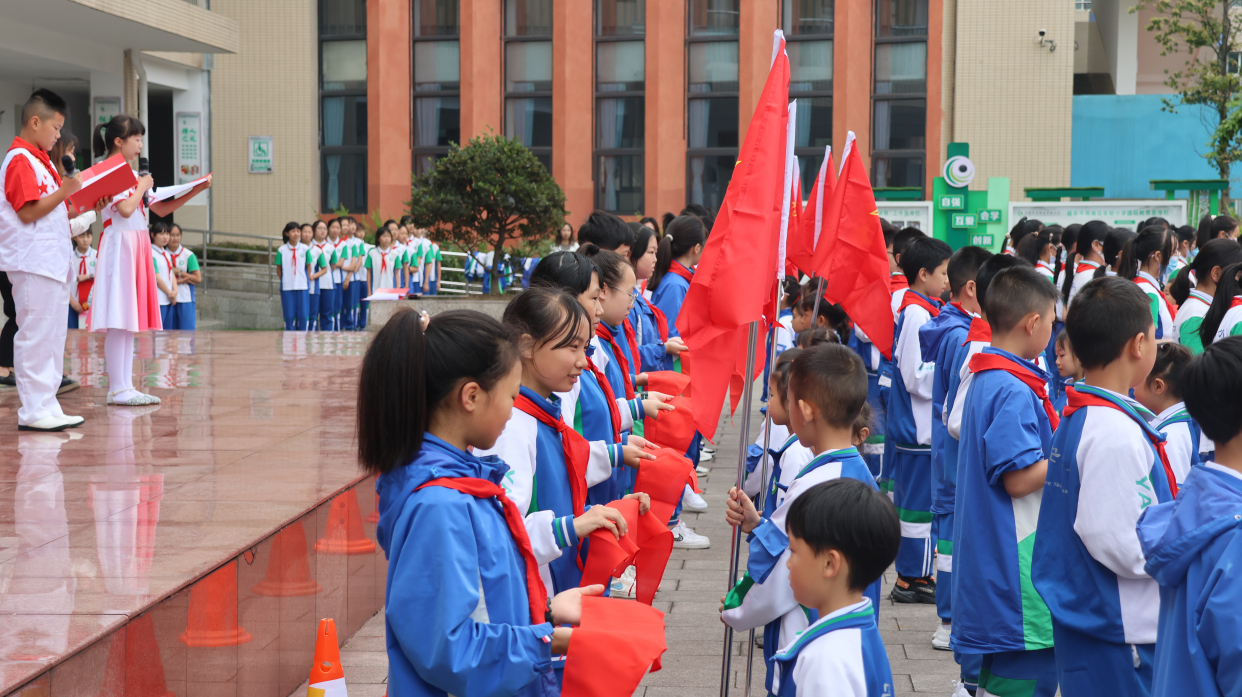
[785,477,902,591]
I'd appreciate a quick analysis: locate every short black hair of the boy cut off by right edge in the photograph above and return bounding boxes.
[1177,335,1242,444]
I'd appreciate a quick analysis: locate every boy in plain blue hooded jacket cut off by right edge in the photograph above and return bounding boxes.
[1139,337,1242,697]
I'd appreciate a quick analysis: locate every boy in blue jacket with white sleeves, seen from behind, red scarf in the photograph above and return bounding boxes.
[1033,277,1175,697]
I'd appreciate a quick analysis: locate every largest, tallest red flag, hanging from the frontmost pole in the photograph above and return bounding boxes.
[677,31,789,440]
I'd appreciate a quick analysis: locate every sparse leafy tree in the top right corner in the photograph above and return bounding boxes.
[1130,0,1242,198]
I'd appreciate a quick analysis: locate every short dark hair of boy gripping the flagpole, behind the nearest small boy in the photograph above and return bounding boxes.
[789,343,867,429]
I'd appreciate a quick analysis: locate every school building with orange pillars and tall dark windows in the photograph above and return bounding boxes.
[0,0,1215,236]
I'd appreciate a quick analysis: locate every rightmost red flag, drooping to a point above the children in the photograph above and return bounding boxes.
[815,132,893,358]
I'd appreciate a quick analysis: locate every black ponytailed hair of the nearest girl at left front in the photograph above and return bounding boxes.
[356,308,518,475]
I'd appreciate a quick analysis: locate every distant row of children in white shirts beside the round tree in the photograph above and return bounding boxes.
[272,216,443,332]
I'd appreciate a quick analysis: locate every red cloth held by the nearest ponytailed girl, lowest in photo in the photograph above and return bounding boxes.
[560,596,668,697]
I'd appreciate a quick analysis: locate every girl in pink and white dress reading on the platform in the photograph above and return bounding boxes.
[89,114,211,406]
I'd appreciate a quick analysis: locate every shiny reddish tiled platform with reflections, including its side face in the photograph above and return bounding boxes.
[0,330,385,697]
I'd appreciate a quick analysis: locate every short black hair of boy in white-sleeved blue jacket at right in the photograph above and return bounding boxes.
[1066,276,1153,369]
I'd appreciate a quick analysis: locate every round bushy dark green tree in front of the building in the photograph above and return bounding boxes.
[406,133,568,294]
